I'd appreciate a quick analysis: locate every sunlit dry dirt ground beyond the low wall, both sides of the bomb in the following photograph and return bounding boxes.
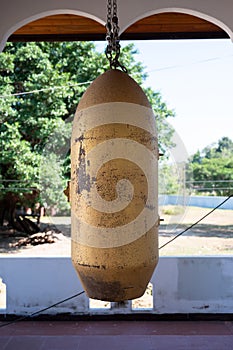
[0,206,233,257]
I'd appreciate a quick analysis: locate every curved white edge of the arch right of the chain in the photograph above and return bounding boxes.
[120,7,233,41]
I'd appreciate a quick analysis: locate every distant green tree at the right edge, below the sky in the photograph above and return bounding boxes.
[188,137,233,196]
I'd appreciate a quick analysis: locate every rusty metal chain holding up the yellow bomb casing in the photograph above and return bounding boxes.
[105,0,127,73]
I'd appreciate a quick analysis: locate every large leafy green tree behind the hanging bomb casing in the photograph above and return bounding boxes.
[0,42,174,228]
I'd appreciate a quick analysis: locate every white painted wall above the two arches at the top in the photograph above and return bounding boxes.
[0,0,233,51]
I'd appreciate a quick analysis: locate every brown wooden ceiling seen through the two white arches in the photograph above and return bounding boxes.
[8,12,228,41]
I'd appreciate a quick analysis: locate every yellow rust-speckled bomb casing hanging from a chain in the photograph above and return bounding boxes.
[70,70,159,301]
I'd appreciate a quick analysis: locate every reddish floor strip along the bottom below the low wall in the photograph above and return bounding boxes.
[0,320,233,350]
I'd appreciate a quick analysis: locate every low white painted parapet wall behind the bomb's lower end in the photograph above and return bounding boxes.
[0,257,233,315]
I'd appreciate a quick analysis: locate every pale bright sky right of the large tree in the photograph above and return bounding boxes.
[95,39,233,155]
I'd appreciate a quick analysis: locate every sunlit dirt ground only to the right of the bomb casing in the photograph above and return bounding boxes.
[159,207,233,256]
